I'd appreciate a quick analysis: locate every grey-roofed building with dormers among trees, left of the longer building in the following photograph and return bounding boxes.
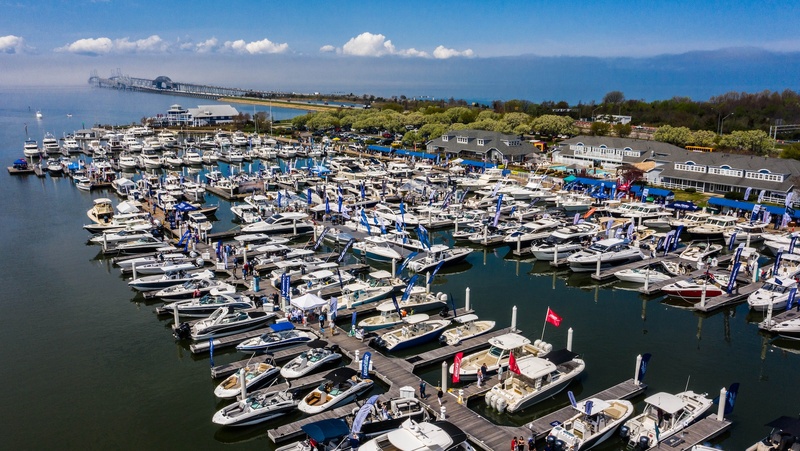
[426,130,537,163]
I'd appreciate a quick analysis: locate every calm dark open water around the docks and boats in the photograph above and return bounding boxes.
[0,87,800,450]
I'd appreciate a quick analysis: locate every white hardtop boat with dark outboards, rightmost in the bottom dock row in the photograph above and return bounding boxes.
[620,390,713,450]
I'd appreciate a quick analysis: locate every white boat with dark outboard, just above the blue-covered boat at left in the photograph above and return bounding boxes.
[181,307,276,341]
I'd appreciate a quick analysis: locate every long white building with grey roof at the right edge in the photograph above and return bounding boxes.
[553,136,800,204]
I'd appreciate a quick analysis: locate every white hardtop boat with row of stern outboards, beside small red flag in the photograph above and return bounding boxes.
[484,349,586,413]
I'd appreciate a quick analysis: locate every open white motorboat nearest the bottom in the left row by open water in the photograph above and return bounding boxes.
[211,390,300,426]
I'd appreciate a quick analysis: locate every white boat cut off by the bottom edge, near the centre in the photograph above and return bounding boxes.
[358,419,473,451]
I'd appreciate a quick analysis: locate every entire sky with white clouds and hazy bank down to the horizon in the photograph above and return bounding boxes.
[0,0,800,102]
